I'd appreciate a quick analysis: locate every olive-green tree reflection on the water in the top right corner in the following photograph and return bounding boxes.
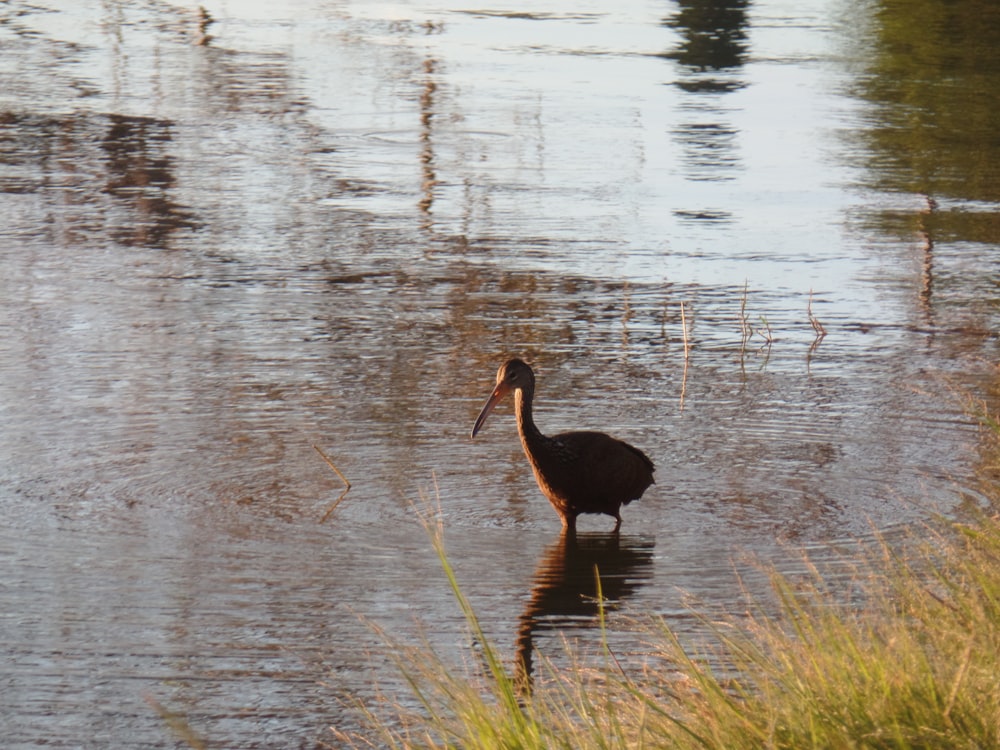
[858,0,1000,204]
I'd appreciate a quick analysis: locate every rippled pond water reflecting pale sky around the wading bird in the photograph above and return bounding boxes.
[0,0,1000,747]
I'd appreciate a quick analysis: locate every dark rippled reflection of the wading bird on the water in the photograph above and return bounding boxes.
[516,532,654,690]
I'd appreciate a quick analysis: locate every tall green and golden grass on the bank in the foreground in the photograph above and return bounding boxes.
[339,420,1000,750]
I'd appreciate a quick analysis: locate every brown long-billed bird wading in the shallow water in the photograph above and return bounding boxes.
[472,358,656,533]
